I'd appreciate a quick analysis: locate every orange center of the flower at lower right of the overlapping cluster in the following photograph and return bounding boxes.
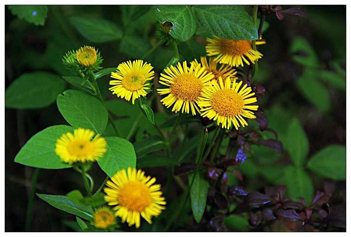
[211,89,244,117]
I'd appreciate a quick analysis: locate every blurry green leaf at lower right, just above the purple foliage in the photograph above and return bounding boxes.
[284,166,314,205]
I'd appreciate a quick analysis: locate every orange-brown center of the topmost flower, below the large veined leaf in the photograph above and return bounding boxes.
[219,39,252,56]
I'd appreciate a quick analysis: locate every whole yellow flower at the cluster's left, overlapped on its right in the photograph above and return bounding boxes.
[157,61,214,115]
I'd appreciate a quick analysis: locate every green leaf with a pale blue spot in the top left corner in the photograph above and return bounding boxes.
[9,5,48,25]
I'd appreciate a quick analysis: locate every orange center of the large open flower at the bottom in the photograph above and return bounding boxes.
[118,181,152,212]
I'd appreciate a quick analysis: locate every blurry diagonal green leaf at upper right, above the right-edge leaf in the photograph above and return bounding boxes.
[297,69,331,112]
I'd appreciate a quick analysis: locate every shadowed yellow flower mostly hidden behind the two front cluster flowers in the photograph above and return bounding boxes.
[191,57,237,81]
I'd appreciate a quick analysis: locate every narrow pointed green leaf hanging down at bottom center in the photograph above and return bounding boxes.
[189,170,210,223]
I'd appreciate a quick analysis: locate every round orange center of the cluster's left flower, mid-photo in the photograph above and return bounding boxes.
[171,73,203,102]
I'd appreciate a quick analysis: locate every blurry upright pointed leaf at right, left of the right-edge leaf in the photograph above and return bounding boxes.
[285,118,309,166]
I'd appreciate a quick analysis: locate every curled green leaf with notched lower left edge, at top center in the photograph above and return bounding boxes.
[155,5,196,41]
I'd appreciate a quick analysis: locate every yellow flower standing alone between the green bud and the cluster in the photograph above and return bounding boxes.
[110,60,155,104]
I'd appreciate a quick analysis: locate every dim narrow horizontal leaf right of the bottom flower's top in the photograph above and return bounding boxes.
[137,154,178,169]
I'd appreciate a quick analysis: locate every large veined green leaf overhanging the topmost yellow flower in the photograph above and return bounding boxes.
[193,5,258,40]
